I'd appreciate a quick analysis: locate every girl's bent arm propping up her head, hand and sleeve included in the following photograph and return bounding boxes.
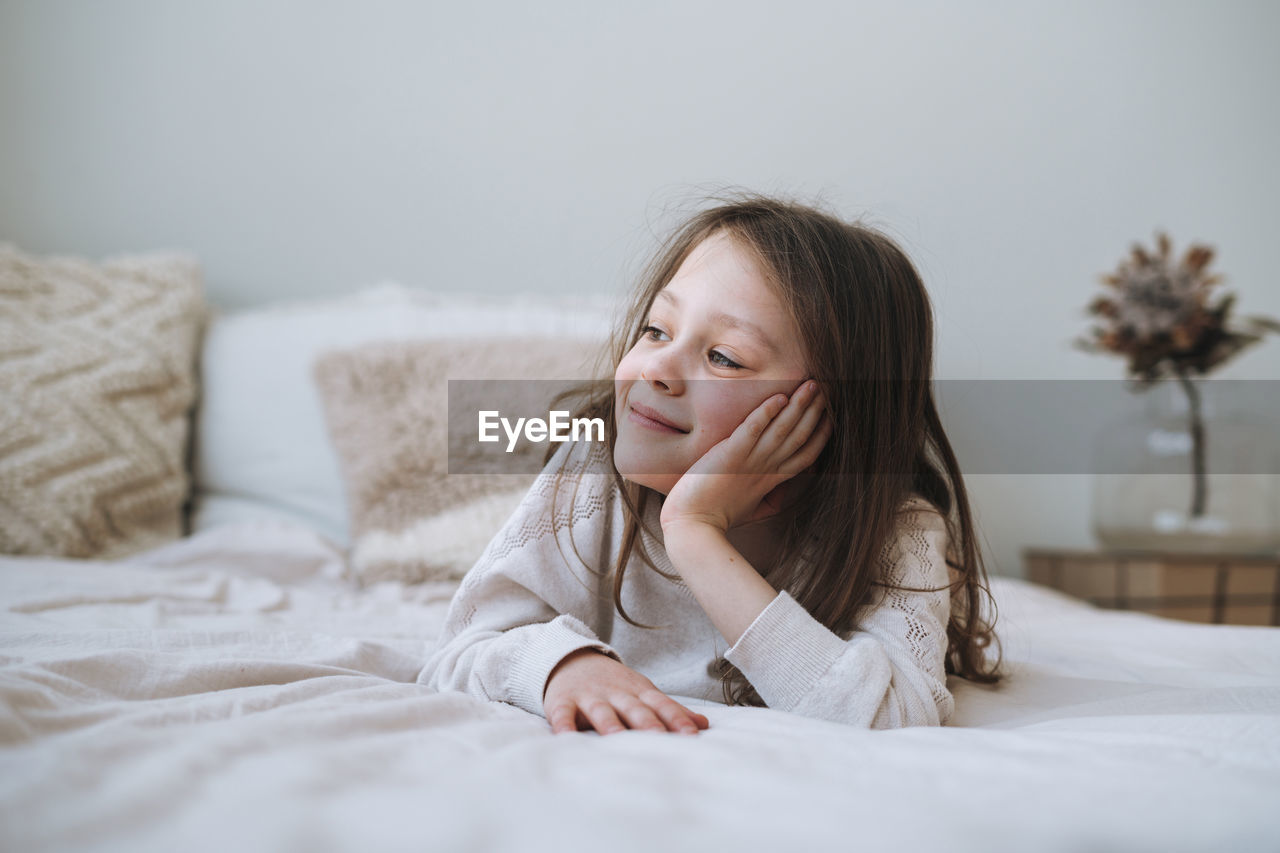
[662,382,954,729]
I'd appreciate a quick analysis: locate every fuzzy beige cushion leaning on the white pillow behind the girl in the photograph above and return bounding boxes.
[312,338,603,583]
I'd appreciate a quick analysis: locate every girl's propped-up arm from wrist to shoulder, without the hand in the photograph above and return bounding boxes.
[663,503,955,729]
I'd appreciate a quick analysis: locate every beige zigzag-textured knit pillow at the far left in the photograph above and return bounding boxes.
[0,245,206,560]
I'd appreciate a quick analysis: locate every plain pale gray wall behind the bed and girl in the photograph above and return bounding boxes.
[0,0,1280,573]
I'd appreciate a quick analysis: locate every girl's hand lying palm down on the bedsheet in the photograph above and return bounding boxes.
[543,648,710,735]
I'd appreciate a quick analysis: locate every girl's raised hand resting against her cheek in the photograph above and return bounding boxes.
[662,380,833,530]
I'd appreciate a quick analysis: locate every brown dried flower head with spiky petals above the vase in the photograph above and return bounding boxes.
[1075,233,1280,384]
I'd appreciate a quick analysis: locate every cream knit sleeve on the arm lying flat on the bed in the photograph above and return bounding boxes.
[417,443,622,716]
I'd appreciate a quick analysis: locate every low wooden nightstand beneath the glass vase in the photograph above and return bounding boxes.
[1023,548,1280,625]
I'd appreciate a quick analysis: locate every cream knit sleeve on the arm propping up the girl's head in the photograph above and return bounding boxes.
[724,510,955,729]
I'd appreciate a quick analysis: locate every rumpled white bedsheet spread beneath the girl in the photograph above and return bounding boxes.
[0,521,1280,852]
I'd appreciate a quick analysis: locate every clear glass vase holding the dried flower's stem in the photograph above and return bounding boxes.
[1093,379,1280,555]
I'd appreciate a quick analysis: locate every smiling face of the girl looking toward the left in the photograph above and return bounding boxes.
[613,232,809,494]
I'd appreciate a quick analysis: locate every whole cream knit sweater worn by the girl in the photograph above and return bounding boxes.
[417,442,955,729]
